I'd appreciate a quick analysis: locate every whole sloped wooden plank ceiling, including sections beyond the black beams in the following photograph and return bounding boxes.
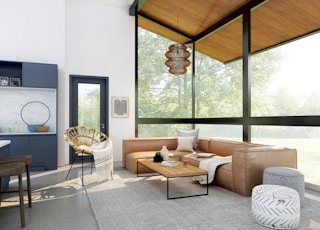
[138,0,320,63]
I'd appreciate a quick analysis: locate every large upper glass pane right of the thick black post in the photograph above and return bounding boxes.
[251,33,320,116]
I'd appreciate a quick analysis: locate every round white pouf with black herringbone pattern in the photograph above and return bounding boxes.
[251,184,300,229]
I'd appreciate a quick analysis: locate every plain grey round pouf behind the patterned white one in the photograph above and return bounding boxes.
[263,167,305,207]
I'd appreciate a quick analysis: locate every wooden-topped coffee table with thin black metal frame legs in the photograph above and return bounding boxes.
[137,159,209,200]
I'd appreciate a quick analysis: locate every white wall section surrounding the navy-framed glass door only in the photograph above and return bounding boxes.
[64,0,135,161]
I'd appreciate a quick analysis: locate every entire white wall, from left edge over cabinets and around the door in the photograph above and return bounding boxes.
[0,0,135,166]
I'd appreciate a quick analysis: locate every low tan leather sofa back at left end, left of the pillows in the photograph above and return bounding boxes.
[122,137,178,167]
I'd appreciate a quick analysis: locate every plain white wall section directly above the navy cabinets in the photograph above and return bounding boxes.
[0,0,65,64]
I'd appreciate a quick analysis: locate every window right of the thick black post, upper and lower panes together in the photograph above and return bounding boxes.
[251,33,320,185]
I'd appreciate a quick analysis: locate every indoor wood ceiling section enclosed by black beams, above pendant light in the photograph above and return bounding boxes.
[139,0,249,37]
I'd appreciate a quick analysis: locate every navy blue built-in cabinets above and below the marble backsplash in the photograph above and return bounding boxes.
[0,61,58,171]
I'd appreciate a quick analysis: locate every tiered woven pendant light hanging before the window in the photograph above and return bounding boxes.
[165,43,191,75]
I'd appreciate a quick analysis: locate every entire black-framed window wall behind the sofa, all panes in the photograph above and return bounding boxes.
[138,12,320,188]
